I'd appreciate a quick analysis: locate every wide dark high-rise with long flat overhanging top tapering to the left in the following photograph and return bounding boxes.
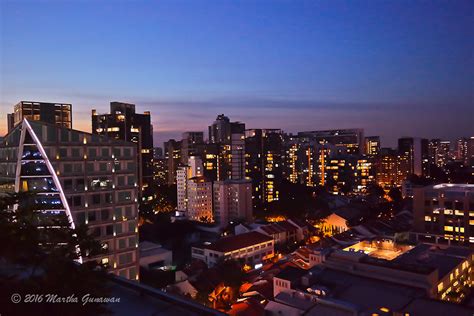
[298,129,364,154]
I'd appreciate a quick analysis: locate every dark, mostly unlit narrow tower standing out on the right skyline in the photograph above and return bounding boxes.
[398,137,429,176]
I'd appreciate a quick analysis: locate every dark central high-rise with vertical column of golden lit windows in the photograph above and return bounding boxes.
[245,129,283,207]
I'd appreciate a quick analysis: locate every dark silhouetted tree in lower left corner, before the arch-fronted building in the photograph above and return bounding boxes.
[0,193,108,315]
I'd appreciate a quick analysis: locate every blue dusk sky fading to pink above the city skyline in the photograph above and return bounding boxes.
[0,0,474,146]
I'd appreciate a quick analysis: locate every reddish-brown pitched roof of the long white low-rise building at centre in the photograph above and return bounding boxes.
[204,232,273,252]
